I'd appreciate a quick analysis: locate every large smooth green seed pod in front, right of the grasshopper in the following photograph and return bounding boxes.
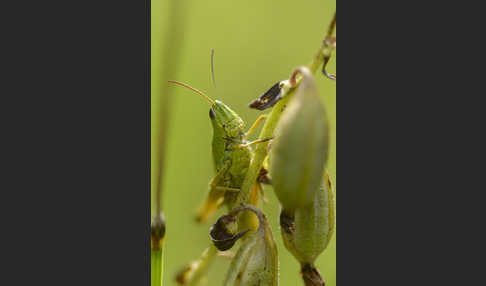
[270,67,329,212]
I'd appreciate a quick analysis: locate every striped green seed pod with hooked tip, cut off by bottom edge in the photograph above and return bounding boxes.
[224,206,278,286]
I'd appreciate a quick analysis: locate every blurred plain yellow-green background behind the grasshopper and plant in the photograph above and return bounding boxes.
[151,0,336,286]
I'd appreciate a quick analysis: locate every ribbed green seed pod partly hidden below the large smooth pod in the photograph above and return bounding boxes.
[280,173,335,285]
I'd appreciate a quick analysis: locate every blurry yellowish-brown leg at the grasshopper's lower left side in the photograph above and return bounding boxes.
[196,161,239,222]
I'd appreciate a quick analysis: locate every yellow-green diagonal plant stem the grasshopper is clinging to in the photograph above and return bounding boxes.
[241,15,336,203]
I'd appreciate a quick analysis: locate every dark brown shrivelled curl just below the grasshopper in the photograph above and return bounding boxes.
[209,215,249,251]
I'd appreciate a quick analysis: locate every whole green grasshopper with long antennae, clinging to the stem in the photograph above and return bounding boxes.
[169,52,271,222]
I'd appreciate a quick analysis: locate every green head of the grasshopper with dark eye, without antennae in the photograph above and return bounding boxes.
[209,100,245,138]
